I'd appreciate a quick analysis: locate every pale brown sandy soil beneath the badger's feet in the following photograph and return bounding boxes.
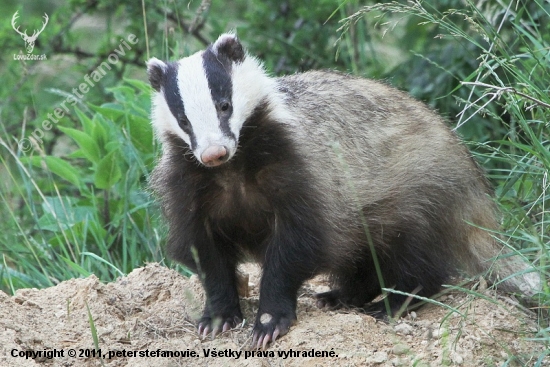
[0,264,550,366]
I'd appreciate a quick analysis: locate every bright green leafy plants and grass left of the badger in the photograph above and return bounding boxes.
[0,81,163,293]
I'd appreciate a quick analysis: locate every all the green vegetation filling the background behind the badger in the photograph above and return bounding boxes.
[0,0,550,352]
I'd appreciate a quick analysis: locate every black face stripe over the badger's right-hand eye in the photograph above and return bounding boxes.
[202,47,236,139]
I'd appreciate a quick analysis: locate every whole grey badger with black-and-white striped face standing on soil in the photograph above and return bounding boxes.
[147,34,540,348]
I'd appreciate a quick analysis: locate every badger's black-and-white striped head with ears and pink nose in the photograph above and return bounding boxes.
[147,34,273,167]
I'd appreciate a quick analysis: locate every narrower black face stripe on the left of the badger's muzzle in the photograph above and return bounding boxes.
[163,62,197,150]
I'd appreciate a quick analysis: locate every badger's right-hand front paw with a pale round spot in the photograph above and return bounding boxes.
[252,313,296,349]
